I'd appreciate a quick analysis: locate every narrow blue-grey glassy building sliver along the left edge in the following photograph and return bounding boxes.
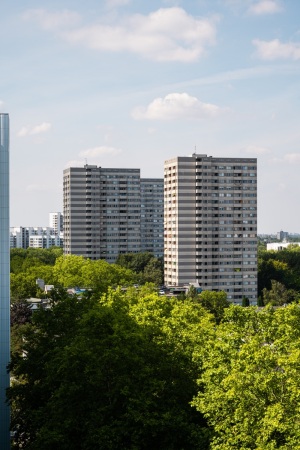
[0,113,10,450]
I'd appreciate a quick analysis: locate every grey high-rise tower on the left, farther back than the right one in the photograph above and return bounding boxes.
[63,165,163,262]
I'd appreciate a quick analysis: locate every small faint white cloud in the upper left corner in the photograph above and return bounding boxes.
[23,9,80,30]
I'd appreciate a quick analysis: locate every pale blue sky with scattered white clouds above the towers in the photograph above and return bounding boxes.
[0,0,300,234]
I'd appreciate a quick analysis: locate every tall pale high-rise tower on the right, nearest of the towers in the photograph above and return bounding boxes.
[164,154,257,304]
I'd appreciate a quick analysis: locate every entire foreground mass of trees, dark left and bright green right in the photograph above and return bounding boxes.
[7,284,300,450]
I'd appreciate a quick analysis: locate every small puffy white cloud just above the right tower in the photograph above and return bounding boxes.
[132,93,222,120]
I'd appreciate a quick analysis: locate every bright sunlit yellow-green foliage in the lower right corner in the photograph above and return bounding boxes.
[193,304,300,450]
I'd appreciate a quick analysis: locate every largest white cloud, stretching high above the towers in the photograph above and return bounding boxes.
[40,7,216,62]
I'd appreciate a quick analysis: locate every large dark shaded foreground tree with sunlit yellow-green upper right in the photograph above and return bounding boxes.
[8,285,214,450]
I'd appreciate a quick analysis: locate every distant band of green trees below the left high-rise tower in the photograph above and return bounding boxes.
[10,248,163,301]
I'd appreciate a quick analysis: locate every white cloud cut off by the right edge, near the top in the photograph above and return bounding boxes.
[252,39,300,60]
